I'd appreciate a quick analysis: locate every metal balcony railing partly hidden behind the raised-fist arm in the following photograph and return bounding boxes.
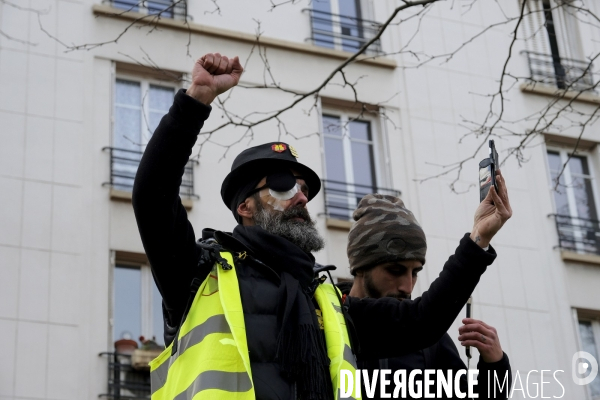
[102,147,199,199]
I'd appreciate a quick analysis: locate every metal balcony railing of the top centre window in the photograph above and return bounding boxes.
[302,8,382,55]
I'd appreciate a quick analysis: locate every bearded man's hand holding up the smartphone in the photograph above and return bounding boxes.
[471,170,512,247]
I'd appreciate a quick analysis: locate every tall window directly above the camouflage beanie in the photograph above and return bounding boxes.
[322,114,399,220]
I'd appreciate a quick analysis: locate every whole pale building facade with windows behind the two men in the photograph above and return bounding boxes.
[0,0,600,400]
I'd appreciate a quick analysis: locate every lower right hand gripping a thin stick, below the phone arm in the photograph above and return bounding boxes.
[458,318,504,364]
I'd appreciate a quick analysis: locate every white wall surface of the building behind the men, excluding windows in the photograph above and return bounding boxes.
[0,0,600,400]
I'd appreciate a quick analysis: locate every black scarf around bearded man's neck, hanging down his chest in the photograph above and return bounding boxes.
[233,225,333,400]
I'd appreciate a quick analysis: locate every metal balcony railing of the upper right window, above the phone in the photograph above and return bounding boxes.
[522,51,594,91]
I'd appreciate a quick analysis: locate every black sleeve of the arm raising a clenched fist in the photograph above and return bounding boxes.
[132,90,211,325]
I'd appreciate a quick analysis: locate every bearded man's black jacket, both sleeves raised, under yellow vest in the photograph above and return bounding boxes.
[133,90,496,399]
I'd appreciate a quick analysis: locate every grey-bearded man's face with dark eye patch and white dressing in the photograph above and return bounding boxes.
[247,170,325,253]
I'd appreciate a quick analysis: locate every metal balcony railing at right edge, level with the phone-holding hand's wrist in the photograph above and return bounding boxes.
[549,214,600,255]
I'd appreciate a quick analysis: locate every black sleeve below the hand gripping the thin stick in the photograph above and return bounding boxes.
[476,353,512,399]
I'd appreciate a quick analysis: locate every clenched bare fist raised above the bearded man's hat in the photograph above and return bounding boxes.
[186,53,244,105]
